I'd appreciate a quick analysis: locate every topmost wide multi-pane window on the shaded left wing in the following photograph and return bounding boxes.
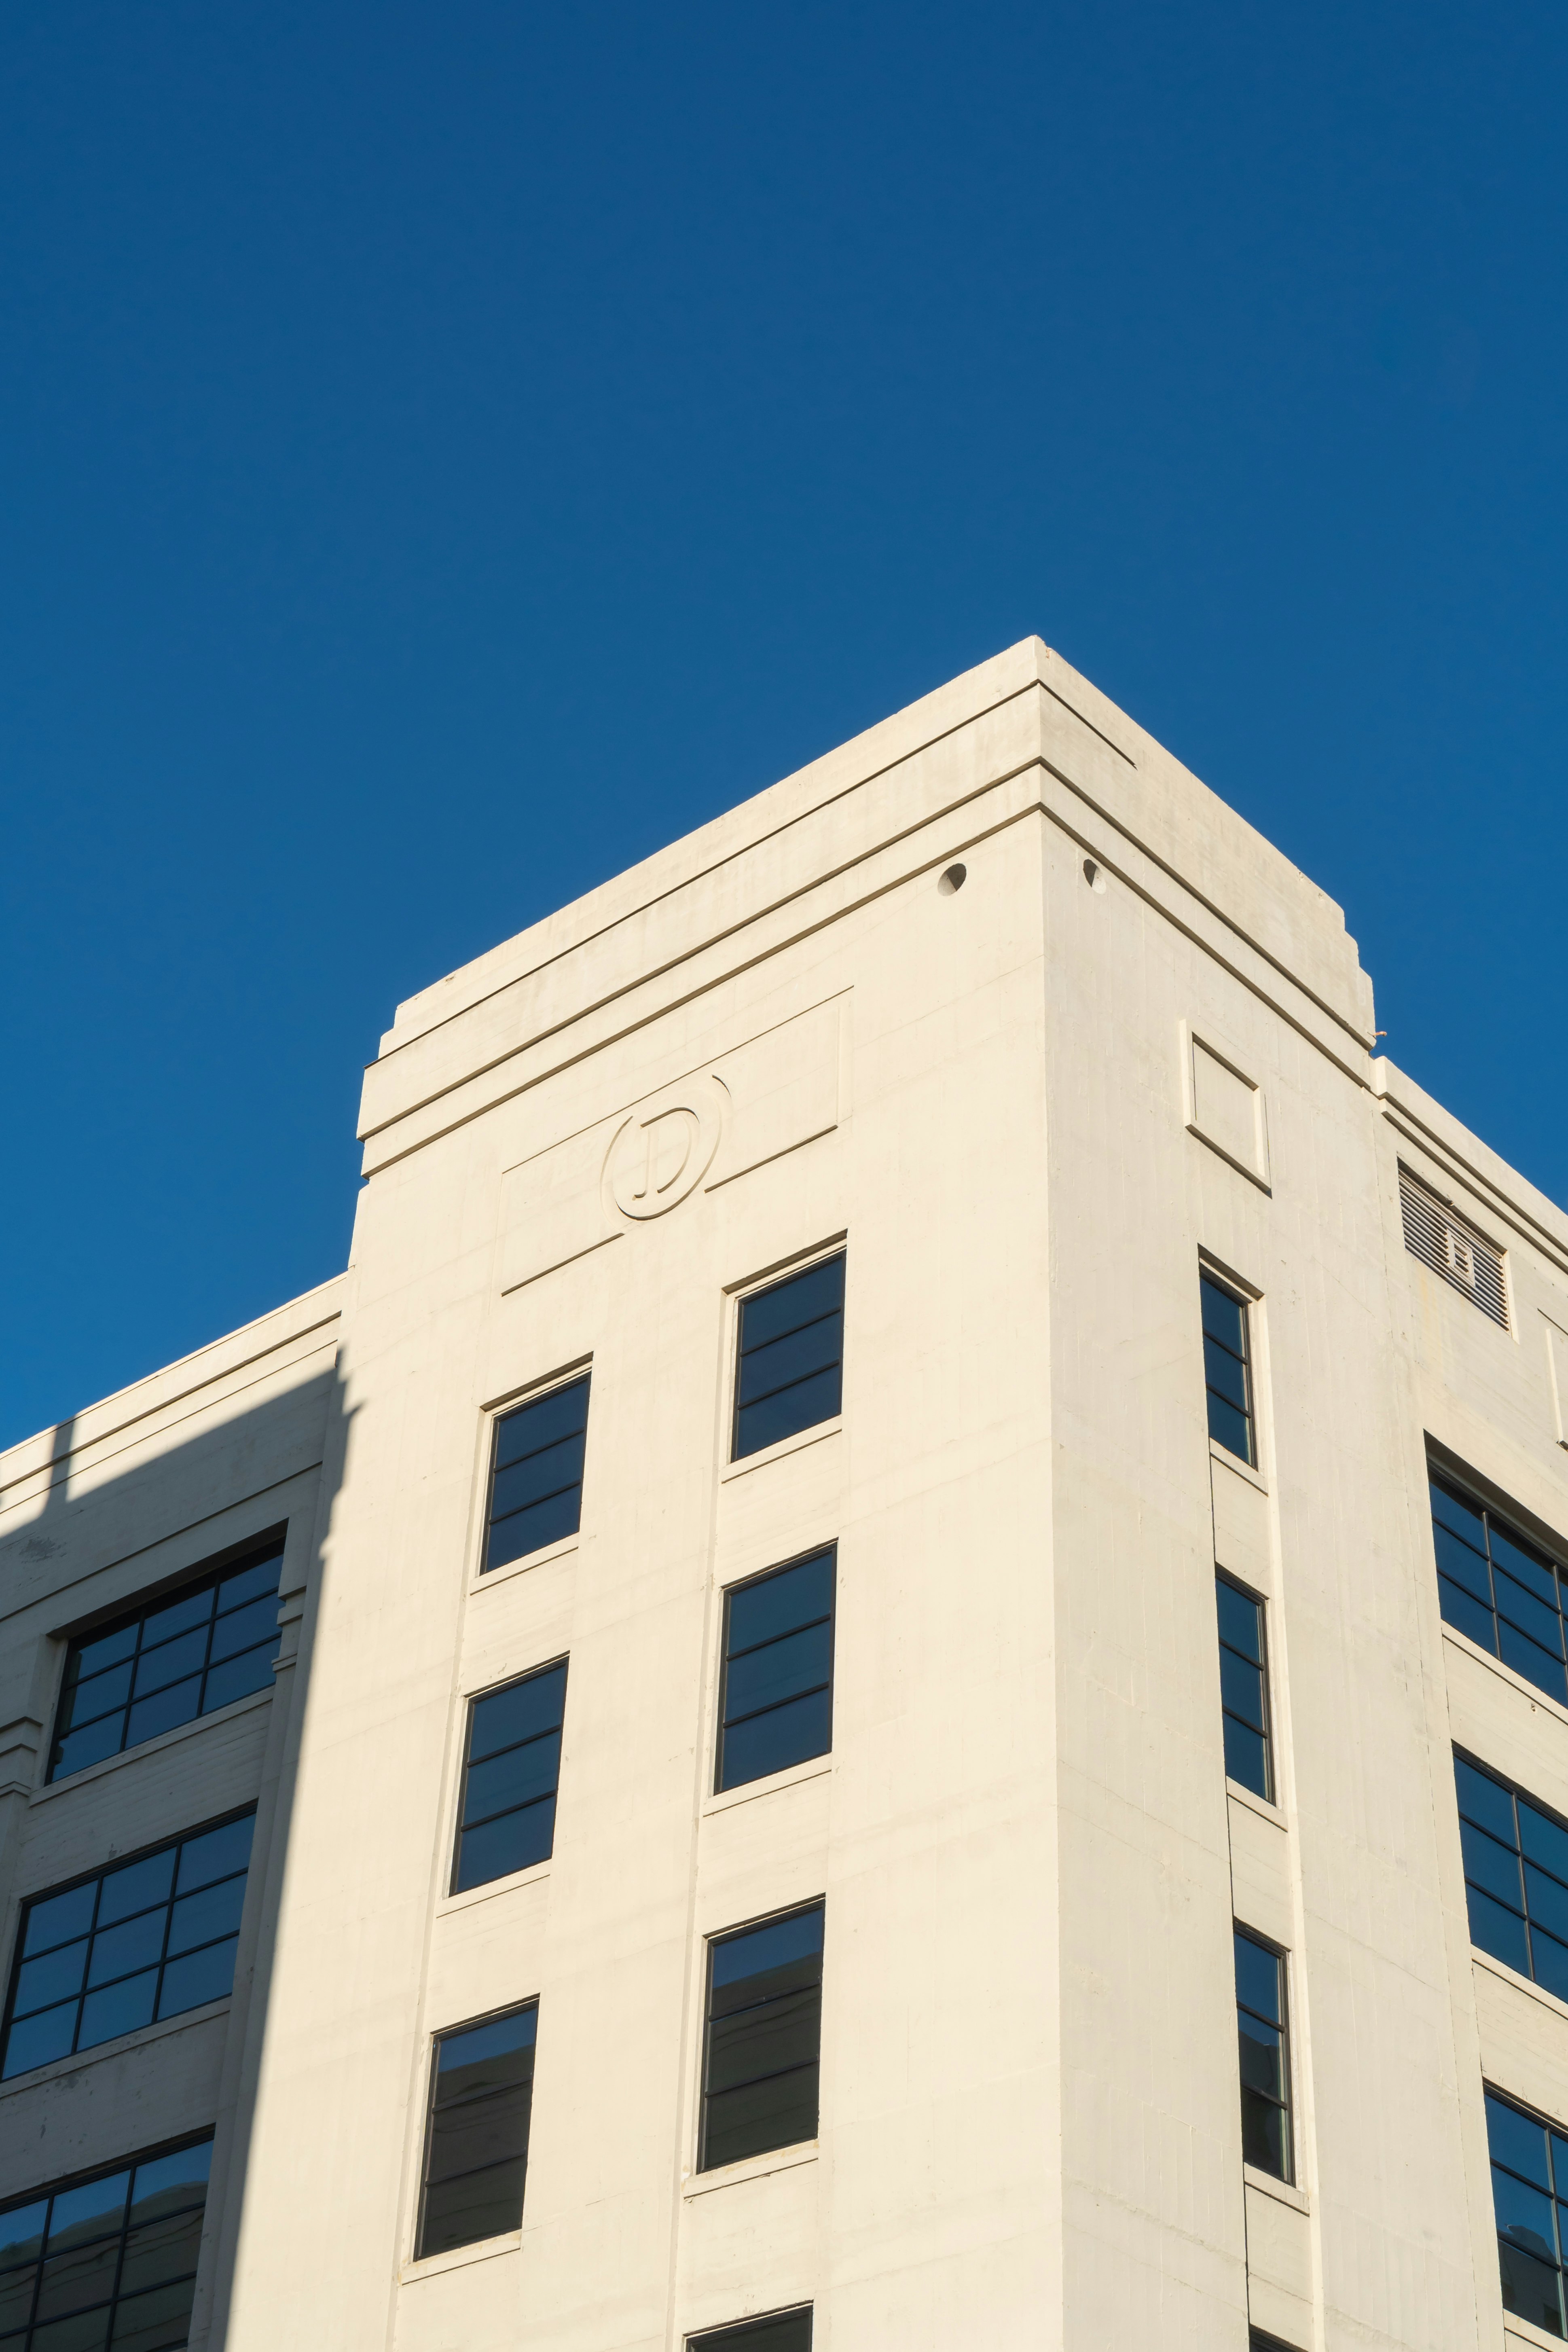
[49,1545,282,1780]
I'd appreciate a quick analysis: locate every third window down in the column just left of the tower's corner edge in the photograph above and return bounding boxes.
[698,1903,823,2171]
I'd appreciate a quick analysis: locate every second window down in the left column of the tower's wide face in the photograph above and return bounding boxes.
[451,1658,567,1891]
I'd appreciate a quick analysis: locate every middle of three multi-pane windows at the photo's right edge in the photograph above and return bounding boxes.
[1453,1755,1568,2002]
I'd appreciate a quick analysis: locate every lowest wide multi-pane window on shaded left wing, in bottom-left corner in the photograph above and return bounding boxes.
[0,2138,212,2352]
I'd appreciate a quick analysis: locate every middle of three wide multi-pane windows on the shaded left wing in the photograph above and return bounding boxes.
[0,1813,254,2079]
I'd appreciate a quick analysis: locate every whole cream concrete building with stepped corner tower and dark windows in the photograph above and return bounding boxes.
[0,640,1568,2352]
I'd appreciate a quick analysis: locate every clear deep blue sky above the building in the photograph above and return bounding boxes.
[0,0,1568,1442]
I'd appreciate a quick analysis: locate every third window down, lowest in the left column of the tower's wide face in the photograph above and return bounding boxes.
[419,2002,538,2260]
